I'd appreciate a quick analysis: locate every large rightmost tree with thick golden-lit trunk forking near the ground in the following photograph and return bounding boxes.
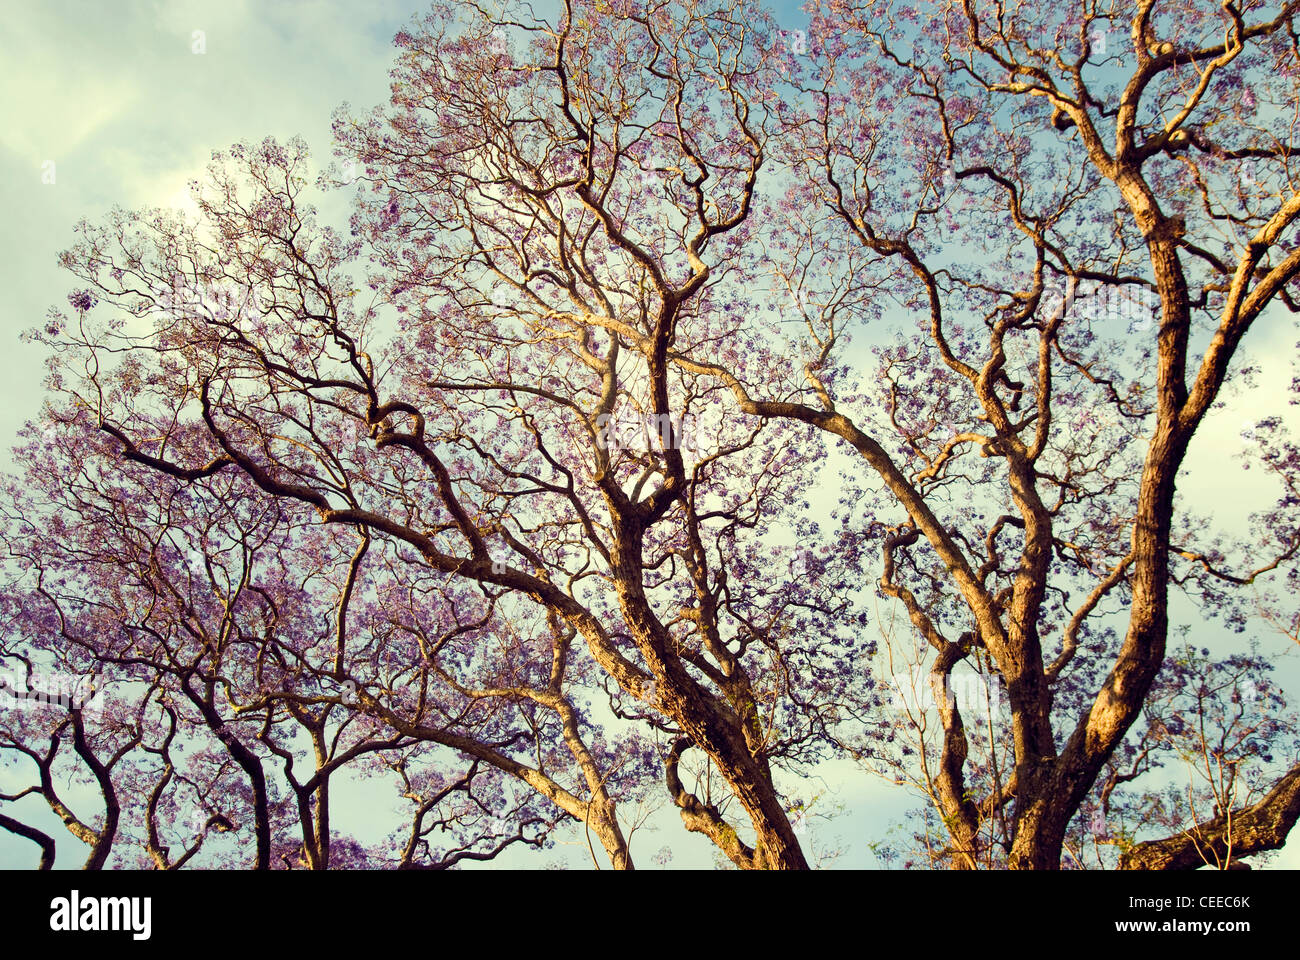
[748,0,1300,868]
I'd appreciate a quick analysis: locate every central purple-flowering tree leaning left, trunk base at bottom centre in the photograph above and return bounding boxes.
[7,1,852,866]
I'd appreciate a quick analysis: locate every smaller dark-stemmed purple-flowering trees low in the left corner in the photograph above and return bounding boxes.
[0,420,569,869]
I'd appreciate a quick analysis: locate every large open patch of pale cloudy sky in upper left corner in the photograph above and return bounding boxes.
[0,0,417,436]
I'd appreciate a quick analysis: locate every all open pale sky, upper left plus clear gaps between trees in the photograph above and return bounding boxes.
[0,0,1300,866]
